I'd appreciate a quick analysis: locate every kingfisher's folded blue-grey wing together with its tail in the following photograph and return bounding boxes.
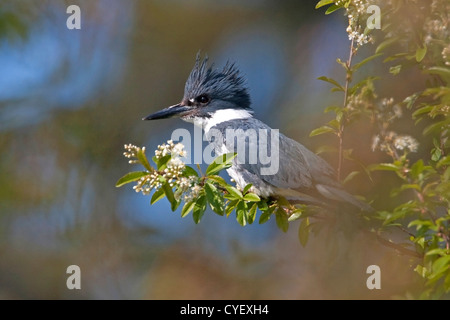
[211,118,373,211]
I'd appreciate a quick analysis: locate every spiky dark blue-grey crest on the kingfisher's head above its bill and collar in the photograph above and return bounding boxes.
[184,53,250,109]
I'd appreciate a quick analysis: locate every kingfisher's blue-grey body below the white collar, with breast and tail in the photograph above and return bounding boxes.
[206,118,371,211]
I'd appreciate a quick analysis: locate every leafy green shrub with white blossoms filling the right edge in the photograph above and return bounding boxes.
[311,0,450,299]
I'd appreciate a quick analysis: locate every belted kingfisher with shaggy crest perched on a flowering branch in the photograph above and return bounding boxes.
[143,54,373,211]
